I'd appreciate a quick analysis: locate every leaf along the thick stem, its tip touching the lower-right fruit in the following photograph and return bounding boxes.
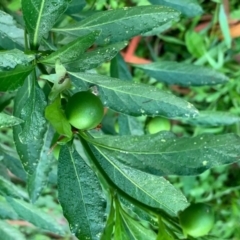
[89,142,188,216]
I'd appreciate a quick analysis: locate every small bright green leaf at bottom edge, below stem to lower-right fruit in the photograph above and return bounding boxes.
[121,205,157,240]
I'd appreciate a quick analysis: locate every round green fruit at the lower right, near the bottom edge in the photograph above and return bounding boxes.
[179,203,214,237]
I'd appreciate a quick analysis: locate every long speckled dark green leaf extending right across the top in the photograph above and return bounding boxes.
[53,6,179,45]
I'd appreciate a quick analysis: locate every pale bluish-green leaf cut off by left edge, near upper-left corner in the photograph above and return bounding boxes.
[0,10,24,50]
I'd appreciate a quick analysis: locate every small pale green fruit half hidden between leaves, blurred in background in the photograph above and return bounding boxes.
[147,117,171,134]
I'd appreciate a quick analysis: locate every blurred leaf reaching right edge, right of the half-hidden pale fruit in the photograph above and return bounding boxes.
[183,111,240,126]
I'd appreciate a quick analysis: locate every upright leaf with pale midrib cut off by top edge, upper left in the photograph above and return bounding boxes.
[22,0,70,48]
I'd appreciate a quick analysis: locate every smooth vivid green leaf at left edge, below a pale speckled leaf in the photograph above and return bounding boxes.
[0,65,34,92]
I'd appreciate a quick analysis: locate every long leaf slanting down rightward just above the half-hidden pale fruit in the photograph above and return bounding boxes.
[70,72,198,118]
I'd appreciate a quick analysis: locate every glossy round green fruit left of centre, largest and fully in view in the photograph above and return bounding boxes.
[65,91,104,130]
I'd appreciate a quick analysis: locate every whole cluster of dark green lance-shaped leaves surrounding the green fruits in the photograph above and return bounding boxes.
[0,0,240,240]
